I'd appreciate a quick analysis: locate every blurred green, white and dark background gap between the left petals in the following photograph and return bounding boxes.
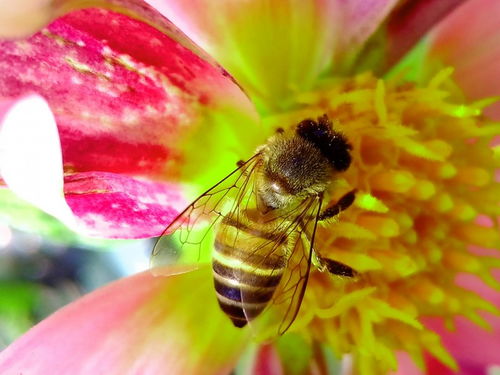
[0,200,153,350]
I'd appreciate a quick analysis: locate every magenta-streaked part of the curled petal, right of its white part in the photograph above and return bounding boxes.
[64,172,187,238]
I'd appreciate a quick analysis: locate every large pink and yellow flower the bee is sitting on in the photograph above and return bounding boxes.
[0,0,500,374]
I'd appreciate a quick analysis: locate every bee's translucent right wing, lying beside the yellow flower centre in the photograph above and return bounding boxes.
[241,197,322,338]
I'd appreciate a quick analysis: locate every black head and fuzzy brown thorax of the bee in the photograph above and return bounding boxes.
[257,115,351,213]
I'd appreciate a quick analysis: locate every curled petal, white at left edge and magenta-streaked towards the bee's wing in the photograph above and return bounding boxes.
[0,95,187,238]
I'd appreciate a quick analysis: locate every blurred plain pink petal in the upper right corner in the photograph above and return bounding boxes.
[430,0,500,119]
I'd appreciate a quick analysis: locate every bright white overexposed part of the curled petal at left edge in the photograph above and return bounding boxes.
[0,95,76,229]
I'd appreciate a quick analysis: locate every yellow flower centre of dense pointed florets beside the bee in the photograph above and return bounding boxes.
[266,69,500,374]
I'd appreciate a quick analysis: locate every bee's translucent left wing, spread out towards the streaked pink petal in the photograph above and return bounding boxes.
[151,154,259,276]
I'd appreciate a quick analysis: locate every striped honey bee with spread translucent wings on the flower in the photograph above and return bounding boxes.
[152,114,356,334]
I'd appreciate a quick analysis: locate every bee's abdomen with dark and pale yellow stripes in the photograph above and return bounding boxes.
[212,218,285,327]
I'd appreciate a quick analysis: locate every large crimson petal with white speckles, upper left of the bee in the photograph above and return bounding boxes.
[0,0,255,178]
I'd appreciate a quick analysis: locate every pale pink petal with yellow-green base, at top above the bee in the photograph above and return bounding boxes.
[148,0,342,109]
